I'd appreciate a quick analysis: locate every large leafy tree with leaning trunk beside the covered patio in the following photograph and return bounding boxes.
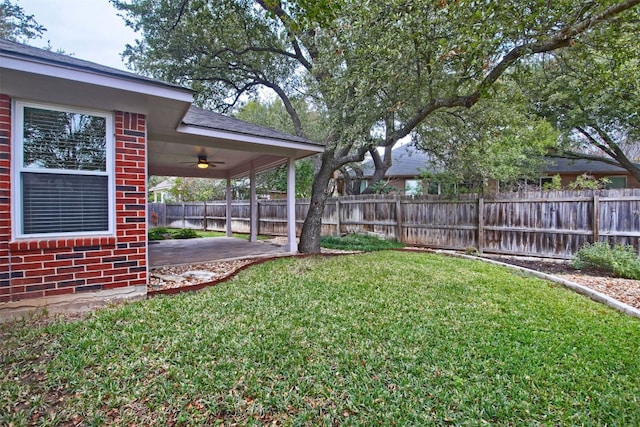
[112,0,640,252]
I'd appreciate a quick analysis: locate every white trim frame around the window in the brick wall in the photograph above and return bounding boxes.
[11,100,116,240]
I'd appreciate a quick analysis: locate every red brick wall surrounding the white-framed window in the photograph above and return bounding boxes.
[0,95,147,302]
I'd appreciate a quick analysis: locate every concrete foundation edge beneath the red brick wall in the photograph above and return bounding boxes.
[0,285,147,322]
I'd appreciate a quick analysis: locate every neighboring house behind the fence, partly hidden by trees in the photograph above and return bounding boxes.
[350,144,640,195]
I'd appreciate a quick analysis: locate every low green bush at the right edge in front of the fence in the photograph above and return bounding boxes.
[572,242,640,280]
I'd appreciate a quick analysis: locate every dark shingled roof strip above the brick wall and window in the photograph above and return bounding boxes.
[0,38,192,92]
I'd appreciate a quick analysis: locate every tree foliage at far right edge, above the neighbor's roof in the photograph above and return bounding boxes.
[523,19,640,181]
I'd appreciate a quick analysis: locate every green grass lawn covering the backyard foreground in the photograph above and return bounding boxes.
[0,251,640,426]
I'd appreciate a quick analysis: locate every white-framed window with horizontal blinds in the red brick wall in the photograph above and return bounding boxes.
[13,102,114,237]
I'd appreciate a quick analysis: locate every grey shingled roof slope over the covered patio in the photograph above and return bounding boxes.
[182,106,322,145]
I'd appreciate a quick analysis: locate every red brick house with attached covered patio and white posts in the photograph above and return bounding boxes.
[0,39,323,317]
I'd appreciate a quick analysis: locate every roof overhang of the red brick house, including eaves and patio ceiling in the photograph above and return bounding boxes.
[0,38,323,178]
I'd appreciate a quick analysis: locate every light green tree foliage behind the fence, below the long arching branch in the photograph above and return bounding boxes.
[414,79,558,192]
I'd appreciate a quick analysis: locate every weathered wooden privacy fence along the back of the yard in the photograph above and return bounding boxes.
[149,189,640,258]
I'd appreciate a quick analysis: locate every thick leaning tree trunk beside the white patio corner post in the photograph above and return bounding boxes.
[298,151,334,254]
